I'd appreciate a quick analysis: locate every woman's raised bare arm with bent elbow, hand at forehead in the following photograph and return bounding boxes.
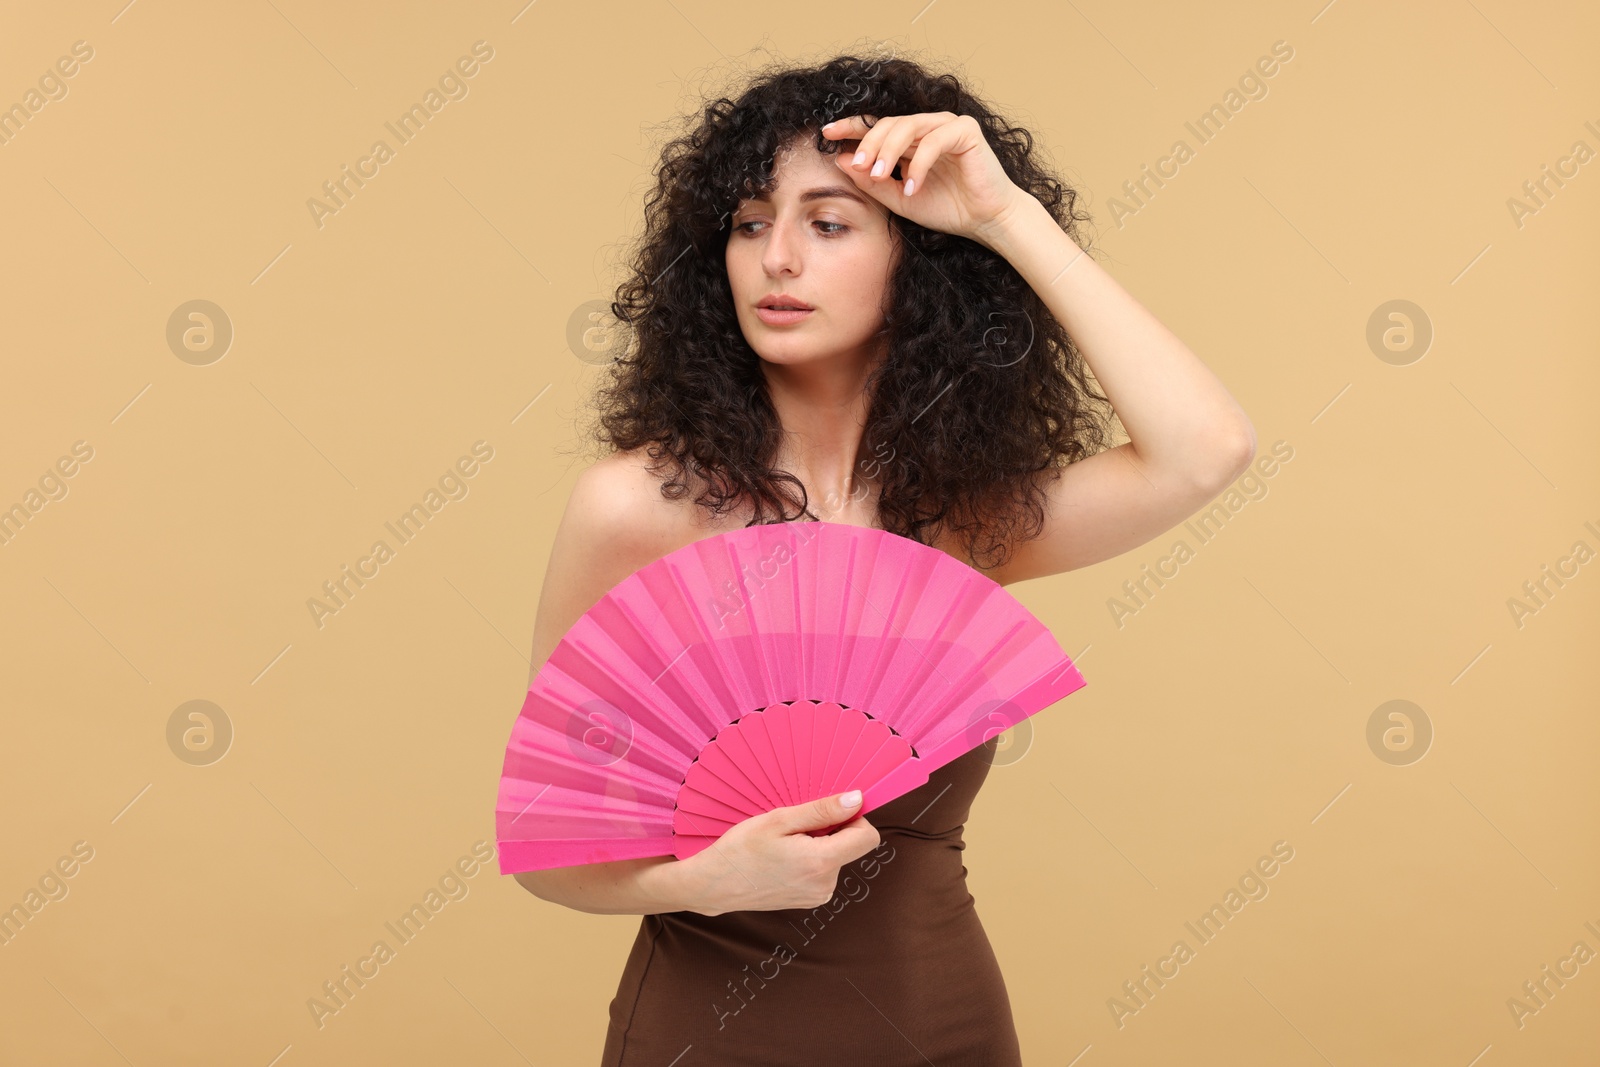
[822,112,1256,585]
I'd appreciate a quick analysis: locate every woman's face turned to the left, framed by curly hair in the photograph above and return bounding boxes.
[726,138,898,374]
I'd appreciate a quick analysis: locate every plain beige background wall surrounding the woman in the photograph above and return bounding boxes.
[0,0,1600,1067]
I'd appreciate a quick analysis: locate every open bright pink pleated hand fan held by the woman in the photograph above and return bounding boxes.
[494,522,1085,873]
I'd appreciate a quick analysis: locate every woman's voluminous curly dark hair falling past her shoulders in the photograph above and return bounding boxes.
[594,45,1110,569]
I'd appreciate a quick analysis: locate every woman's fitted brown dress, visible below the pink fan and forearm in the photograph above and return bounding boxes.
[602,739,1022,1067]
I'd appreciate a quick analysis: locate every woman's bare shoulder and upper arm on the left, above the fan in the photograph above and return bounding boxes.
[528,450,694,685]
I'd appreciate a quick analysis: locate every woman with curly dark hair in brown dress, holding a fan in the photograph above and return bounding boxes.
[517,56,1254,1067]
